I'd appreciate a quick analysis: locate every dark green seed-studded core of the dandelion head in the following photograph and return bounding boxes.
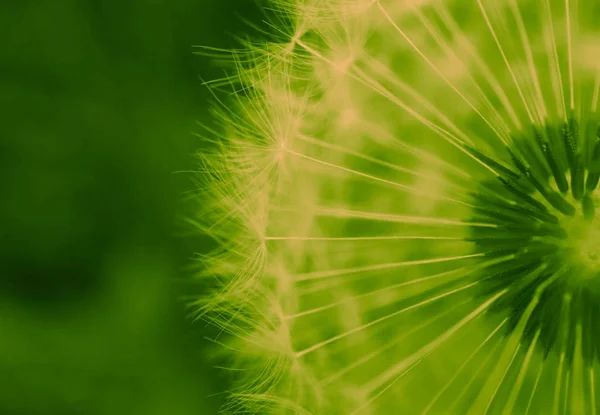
[467,116,600,365]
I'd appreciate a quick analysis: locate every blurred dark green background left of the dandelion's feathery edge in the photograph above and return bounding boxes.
[0,0,258,415]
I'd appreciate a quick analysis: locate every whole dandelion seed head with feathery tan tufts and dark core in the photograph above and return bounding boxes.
[196,0,600,415]
